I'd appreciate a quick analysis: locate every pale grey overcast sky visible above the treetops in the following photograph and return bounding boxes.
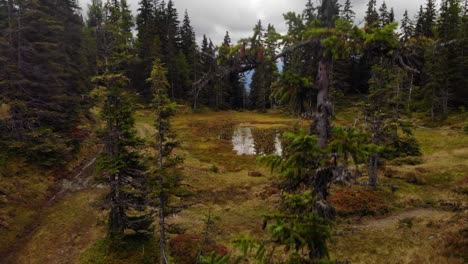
[79,0,432,45]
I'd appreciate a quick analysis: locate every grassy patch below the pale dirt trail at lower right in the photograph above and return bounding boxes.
[331,212,463,264]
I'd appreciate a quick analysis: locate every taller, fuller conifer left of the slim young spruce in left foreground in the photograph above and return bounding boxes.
[94,72,152,238]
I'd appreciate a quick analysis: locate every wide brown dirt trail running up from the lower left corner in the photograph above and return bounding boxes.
[0,153,102,264]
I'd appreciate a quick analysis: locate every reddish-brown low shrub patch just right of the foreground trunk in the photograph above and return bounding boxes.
[330,188,391,216]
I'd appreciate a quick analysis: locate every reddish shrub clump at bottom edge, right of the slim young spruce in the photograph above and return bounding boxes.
[169,234,229,264]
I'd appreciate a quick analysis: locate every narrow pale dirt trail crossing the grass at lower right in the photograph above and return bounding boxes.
[359,208,453,229]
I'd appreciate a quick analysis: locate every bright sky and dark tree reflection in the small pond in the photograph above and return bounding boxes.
[232,127,283,155]
